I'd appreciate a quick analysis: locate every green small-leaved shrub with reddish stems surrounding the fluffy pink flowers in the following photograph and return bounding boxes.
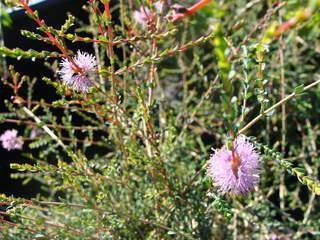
[0,0,320,239]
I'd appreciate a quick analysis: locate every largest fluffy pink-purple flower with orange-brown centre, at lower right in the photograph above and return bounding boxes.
[208,136,259,194]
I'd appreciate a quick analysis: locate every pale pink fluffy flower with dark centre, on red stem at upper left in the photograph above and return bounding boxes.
[59,51,97,93]
